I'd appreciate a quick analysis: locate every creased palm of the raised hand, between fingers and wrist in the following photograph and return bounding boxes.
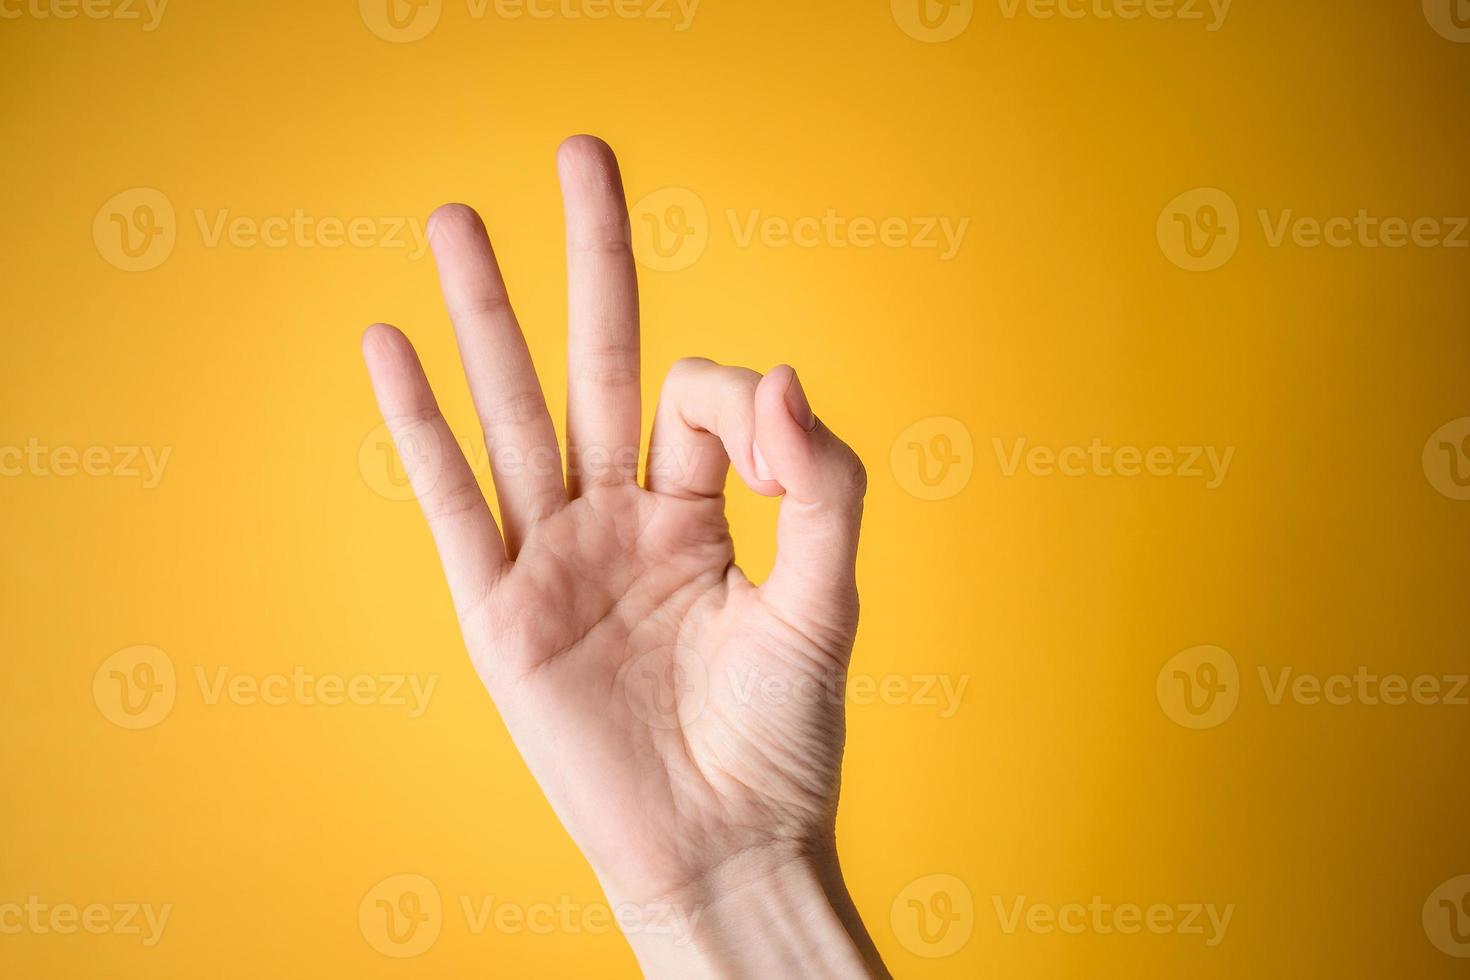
[479,488,844,899]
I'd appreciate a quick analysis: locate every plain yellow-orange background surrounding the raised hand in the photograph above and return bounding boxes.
[0,0,1470,977]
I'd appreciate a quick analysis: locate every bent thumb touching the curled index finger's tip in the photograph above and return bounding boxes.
[754,364,867,640]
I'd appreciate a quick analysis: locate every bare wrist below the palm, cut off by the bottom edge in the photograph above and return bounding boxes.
[614,845,888,977]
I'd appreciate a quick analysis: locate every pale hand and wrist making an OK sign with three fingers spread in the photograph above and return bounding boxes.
[363,137,886,977]
